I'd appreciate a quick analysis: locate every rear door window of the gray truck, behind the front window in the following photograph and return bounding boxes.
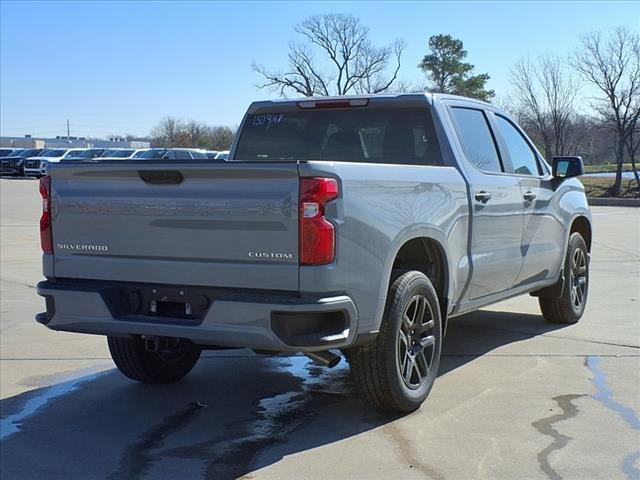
[451,108,502,172]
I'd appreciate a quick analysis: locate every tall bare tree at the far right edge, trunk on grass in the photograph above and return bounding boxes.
[571,27,640,196]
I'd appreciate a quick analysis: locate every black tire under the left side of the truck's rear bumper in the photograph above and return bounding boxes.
[107,337,201,383]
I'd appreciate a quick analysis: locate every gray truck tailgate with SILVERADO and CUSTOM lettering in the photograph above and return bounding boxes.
[51,162,299,290]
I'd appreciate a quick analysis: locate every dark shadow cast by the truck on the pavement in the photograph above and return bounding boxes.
[0,311,561,480]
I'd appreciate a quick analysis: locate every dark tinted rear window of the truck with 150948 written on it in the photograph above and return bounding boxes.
[235,107,442,165]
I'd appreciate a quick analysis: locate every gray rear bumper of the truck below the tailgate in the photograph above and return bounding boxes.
[36,280,357,351]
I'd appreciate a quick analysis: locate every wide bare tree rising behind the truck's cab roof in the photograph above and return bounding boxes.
[252,14,405,97]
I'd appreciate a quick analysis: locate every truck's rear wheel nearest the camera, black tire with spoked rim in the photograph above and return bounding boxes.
[349,271,442,413]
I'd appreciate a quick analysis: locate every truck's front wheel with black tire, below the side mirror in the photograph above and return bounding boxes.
[538,232,589,324]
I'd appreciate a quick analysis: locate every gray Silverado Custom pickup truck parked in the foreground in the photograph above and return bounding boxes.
[37,94,592,412]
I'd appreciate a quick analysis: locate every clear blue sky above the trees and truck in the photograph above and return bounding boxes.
[0,1,640,137]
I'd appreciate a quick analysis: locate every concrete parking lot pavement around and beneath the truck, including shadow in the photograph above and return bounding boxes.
[0,179,640,480]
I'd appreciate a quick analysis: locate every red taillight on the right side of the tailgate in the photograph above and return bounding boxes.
[300,177,340,265]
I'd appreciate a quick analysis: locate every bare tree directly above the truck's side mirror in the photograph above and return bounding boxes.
[511,55,579,159]
